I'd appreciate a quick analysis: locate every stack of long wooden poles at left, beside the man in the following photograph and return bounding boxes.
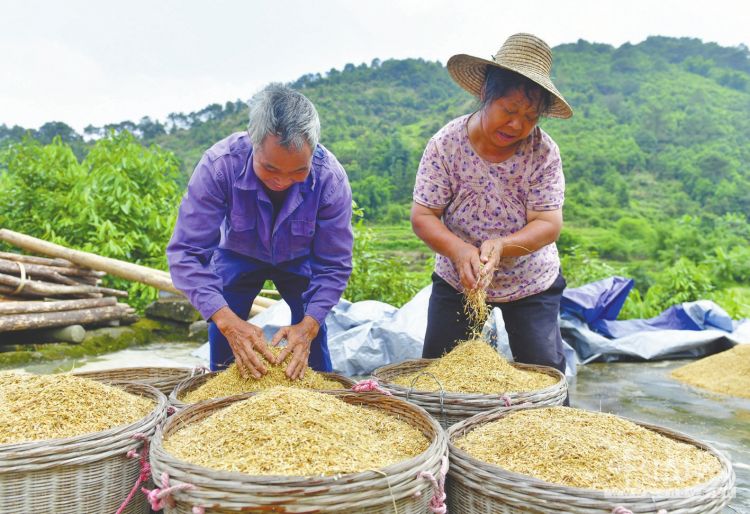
[0,229,276,340]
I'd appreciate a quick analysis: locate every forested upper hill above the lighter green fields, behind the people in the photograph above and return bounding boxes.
[0,37,750,228]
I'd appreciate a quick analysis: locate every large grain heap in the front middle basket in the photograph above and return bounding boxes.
[164,387,429,476]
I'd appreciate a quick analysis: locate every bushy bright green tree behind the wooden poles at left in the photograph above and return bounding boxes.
[0,132,180,307]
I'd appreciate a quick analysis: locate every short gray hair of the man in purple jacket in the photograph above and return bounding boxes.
[247,83,320,152]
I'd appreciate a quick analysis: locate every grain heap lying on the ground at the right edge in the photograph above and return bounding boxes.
[671,344,750,398]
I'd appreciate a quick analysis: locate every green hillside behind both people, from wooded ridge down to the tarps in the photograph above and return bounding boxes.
[0,37,750,315]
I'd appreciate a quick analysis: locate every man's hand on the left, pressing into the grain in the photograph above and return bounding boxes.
[211,307,274,379]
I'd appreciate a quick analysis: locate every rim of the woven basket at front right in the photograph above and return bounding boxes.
[446,405,735,502]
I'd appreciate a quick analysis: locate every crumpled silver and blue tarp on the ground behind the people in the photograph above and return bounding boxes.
[192,277,750,376]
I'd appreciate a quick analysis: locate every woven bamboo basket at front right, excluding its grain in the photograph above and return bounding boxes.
[447,407,735,514]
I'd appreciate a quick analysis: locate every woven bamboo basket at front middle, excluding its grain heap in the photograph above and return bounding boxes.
[151,391,448,514]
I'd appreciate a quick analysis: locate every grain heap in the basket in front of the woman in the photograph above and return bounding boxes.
[392,339,557,394]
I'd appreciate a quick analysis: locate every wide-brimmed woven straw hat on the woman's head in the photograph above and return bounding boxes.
[448,34,573,118]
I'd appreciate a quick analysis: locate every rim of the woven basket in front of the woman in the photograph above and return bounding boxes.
[372,359,567,401]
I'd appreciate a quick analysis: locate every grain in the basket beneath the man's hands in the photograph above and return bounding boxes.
[178,347,344,403]
